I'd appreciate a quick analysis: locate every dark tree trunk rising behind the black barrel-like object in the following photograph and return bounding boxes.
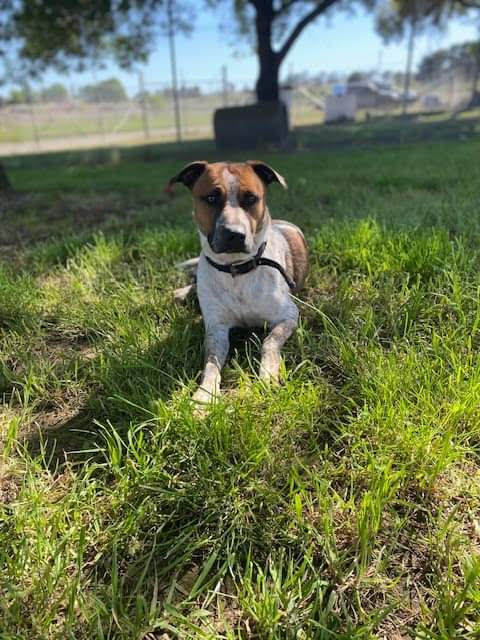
[254,0,280,102]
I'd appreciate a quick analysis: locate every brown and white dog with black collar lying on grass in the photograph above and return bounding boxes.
[169,161,308,404]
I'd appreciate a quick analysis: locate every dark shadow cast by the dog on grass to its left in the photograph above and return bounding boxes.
[24,303,203,469]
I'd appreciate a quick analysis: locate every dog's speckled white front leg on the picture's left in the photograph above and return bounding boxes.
[193,325,230,404]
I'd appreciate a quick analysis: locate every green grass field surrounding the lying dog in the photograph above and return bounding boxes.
[0,121,480,640]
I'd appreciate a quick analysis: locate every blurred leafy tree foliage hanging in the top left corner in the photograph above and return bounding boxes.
[0,0,191,190]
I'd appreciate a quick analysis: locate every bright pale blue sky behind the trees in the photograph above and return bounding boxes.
[29,4,478,94]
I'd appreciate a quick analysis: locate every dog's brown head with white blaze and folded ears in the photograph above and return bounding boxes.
[169,160,287,253]
